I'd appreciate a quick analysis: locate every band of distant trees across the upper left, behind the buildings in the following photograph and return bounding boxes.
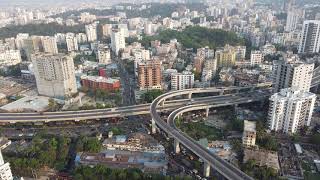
[0,23,85,38]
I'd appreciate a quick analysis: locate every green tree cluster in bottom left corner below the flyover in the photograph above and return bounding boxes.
[4,135,71,176]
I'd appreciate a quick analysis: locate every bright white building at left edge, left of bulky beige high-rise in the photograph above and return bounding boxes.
[0,50,21,67]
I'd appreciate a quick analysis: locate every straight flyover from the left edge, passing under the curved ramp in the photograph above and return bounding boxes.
[0,95,258,123]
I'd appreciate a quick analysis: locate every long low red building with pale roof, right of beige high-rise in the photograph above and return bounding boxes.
[81,76,120,91]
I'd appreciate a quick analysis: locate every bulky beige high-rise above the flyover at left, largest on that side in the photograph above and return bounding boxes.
[32,54,77,99]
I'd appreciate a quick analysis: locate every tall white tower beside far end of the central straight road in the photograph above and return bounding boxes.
[111,29,126,56]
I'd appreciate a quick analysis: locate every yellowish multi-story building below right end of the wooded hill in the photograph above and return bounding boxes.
[216,46,237,68]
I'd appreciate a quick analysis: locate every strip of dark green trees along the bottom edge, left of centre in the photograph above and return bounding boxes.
[73,165,192,180]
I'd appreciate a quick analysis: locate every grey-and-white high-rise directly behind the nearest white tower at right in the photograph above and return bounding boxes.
[273,57,314,92]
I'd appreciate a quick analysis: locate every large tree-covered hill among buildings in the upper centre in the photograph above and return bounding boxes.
[141,26,245,49]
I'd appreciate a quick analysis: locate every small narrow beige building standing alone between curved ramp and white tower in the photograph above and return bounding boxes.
[242,120,256,147]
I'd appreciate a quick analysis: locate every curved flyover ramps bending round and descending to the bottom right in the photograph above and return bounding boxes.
[150,84,271,180]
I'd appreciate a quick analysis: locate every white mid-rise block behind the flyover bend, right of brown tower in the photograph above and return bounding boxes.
[171,71,194,90]
